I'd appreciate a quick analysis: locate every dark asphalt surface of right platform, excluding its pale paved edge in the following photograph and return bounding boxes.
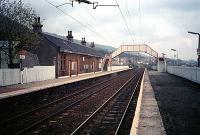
[149,71,200,135]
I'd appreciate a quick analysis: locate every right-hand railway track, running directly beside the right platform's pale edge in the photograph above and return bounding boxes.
[71,71,143,135]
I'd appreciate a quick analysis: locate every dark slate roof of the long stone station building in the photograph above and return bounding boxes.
[42,33,103,57]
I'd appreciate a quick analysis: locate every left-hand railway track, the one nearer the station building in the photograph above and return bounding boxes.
[0,71,138,134]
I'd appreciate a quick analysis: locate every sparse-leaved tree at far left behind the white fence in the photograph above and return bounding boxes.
[0,0,38,68]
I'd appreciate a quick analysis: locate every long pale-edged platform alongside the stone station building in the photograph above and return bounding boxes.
[0,68,128,99]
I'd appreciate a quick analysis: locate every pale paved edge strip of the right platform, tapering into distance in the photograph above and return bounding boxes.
[130,71,166,135]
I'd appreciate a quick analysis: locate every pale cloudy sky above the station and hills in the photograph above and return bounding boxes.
[22,0,200,60]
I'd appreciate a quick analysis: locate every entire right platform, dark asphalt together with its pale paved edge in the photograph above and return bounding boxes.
[131,71,200,135]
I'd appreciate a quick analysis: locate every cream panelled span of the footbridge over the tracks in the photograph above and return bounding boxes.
[111,44,158,58]
